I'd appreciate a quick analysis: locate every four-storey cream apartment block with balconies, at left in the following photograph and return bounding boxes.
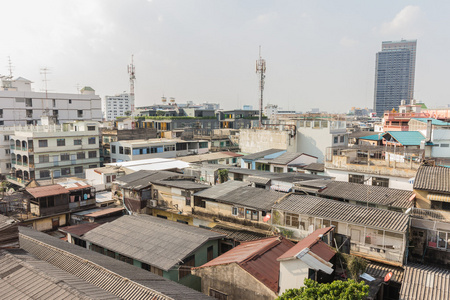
[8,118,100,185]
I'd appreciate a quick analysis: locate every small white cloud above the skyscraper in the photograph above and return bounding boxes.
[377,5,421,35]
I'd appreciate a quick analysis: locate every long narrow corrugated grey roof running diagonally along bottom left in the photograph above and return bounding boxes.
[20,227,211,300]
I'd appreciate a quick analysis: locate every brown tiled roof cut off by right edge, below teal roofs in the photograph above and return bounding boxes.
[413,166,450,193]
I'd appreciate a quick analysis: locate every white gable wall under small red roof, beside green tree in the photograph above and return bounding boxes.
[279,259,309,295]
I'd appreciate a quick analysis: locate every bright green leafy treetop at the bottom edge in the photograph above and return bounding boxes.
[277,278,369,300]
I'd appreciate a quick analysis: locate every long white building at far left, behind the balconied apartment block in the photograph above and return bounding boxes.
[0,77,102,126]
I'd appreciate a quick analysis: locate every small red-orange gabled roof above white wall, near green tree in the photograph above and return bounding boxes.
[278,227,336,261]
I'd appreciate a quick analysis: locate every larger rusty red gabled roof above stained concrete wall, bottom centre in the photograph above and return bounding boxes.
[195,237,294,293]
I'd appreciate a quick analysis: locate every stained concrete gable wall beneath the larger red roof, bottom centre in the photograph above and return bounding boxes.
[192,263,277,300]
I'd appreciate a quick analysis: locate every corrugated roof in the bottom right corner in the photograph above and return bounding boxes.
[400,264,450,300]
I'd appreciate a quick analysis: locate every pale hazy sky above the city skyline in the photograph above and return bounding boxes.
[0,0,450,113]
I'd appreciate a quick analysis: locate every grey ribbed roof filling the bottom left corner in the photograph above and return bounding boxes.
[0,249,119,299]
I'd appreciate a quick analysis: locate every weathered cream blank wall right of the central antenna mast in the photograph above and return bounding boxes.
[239,129,289,153]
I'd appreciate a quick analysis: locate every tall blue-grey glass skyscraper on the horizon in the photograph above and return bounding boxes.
[373,40,417,117]
